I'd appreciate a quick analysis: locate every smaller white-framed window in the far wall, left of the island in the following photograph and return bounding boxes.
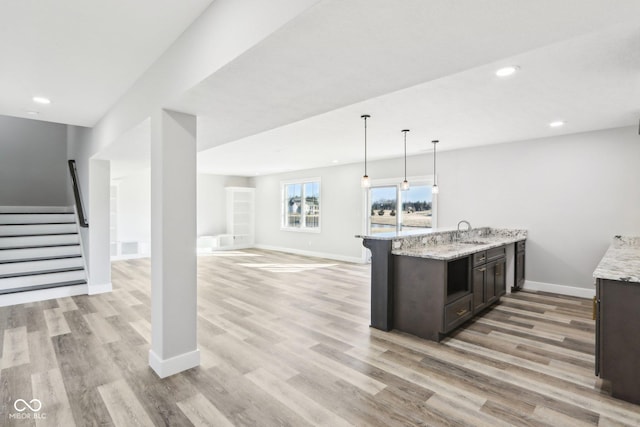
[282,178,320,232]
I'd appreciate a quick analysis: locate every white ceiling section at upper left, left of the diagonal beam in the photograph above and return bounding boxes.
[0,0,212,127]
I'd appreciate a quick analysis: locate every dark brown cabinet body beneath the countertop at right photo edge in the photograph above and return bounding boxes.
[595,279,640,404]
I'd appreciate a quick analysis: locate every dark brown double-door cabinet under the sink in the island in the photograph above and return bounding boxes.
[471,246,507,313]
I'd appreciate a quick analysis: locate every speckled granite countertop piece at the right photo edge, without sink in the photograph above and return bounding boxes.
[593,236,640,283]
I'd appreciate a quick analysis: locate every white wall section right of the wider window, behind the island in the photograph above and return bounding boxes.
[438,127,640,290]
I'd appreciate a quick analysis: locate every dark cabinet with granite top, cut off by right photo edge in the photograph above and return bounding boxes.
[593,236,640,404]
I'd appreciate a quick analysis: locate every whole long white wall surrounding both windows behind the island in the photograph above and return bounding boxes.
[255,127,640,292]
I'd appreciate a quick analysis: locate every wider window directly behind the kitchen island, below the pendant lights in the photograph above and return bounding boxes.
[367,180,435,234]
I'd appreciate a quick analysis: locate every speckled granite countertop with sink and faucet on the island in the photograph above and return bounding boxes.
[356,227,527,261]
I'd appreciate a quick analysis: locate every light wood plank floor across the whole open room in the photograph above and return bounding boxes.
[0,250,640,427]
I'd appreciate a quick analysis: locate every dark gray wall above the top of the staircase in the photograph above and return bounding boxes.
[0,116,69,206]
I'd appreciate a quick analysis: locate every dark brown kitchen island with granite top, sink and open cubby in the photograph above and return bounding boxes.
[357,227,527,341]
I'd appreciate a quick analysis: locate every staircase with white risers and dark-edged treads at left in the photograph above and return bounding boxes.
[0,206,87,305]
